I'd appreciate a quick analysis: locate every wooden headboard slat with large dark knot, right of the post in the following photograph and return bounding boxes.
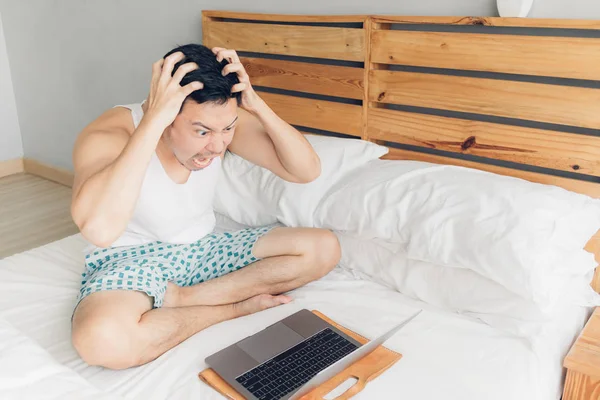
[368,108,600,176]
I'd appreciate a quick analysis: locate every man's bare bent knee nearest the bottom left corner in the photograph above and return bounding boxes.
[71,316,139,369]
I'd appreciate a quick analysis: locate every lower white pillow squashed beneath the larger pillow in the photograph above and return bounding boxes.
[337,233,597,342]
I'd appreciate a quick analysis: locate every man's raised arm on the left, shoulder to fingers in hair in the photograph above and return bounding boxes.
[71,53,202,247]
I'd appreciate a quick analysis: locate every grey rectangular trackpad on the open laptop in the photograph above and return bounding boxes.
[237,322,304,363]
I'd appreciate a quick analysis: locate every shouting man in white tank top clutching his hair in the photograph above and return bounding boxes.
[72,45,340,369]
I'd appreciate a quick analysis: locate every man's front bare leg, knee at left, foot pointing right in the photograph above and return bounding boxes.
[72,290,289,369]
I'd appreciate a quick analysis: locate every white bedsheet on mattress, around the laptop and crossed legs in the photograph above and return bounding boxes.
[0,235,588,400]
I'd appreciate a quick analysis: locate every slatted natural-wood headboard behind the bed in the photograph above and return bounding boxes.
[202,11,600,292]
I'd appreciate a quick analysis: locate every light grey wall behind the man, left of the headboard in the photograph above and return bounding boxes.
[0,0,210,169]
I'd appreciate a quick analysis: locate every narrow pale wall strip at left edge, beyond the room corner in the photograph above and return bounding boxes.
[0,9,23,161]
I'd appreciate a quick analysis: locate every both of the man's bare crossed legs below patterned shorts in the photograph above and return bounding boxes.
[72,228,340,369]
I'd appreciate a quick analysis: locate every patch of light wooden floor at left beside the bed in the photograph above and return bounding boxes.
[0,174,78,258]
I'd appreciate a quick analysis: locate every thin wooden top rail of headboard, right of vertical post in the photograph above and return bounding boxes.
[373,15,600,29]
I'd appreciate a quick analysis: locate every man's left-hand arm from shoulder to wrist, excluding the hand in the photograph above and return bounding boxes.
[71,108,169,247]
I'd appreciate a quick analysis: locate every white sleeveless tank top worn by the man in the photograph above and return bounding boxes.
[86,104,221,252]
